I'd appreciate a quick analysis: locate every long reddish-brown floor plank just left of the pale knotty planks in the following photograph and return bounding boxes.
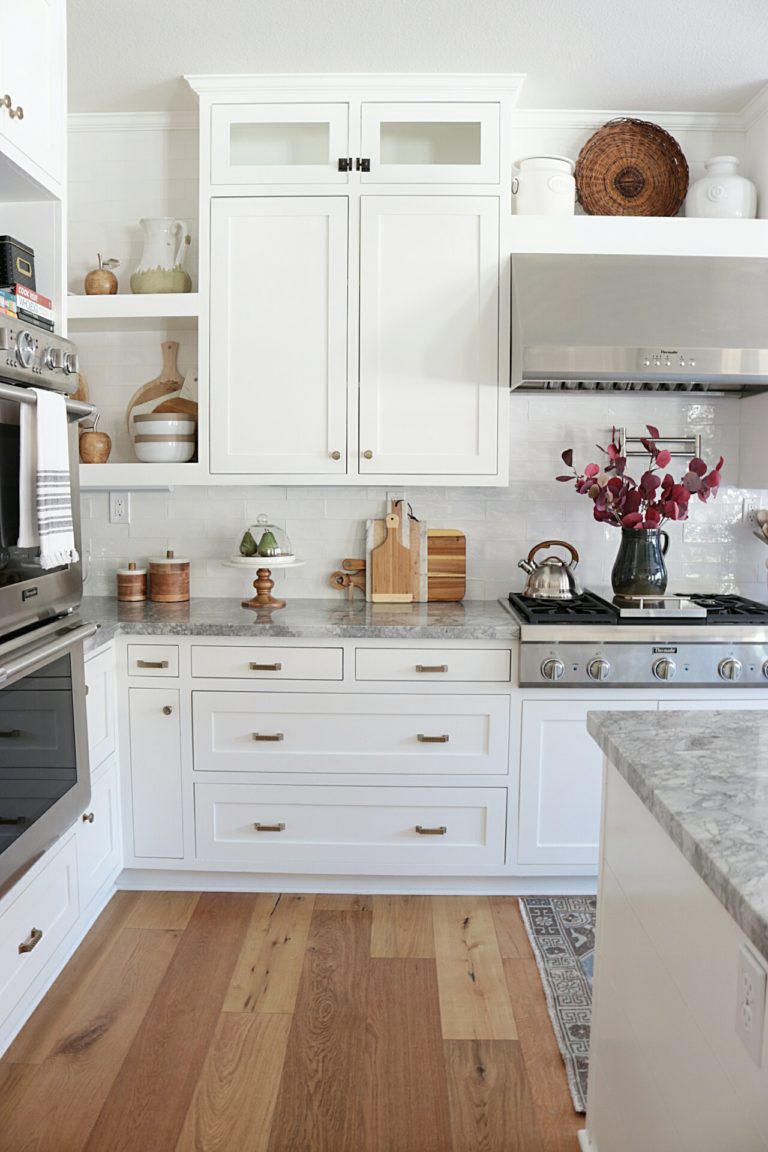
[85,893,253,1152]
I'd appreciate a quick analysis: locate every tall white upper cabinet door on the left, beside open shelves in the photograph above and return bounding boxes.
[211,196,348,476]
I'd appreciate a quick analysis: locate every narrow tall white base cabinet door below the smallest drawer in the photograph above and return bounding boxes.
[128,688,184,858]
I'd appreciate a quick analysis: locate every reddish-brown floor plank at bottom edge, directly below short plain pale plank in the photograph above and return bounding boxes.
[359,960,451,1152]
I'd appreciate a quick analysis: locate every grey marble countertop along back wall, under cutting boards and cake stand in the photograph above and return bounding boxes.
[79,596,519,651]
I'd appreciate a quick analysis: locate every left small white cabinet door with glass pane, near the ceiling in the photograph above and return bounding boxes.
[211,104,351,184]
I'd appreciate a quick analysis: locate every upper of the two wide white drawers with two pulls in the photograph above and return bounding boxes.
[192,692,509,775]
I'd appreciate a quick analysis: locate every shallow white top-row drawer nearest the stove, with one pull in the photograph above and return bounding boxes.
[355,647,512,683]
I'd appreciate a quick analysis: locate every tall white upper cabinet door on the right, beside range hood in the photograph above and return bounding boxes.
[359,196,500,479]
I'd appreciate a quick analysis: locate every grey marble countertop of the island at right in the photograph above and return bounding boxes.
[587,711,768,960]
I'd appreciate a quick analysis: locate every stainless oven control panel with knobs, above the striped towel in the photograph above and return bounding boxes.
[0,317,79,395]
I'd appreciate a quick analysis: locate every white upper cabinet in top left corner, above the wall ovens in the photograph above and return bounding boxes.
[0,0,66,191]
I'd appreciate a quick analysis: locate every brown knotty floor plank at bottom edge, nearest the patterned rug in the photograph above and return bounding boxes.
[443,1040,541,1152]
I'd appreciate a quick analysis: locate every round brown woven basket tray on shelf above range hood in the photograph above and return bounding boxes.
[575,118,689,215]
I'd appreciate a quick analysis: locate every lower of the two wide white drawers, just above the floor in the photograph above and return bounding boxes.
[195,783,507,870]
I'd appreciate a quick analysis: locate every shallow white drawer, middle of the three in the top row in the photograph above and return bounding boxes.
[192,644,343,680]
